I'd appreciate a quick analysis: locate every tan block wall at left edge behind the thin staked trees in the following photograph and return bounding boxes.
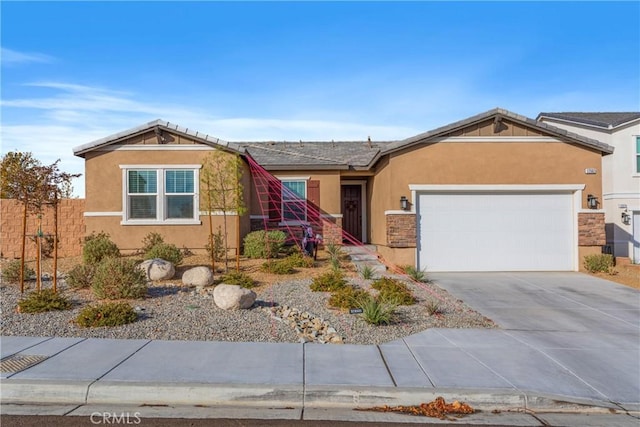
[0,199,85,259]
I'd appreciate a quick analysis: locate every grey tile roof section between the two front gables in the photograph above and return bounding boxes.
[238,141,388,170]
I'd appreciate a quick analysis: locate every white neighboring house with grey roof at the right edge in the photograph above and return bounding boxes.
[537,112,640,264]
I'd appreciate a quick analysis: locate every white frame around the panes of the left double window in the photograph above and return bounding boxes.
[120,165,202,225]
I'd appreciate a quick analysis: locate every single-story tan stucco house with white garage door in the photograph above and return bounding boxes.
[74,109,613,271]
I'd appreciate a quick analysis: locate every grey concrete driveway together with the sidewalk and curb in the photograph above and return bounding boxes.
[0,273,640,425]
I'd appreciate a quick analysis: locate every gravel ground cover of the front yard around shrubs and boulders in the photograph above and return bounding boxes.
[0,275,495,344]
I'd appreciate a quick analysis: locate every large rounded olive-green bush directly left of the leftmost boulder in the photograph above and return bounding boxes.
[92,258,147,299]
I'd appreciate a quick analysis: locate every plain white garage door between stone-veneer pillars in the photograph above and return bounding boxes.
[417,192,574,271]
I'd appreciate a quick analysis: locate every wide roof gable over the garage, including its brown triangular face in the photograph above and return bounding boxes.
[381,108,613,155]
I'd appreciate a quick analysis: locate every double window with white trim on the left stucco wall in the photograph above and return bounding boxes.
[121,165,200,224]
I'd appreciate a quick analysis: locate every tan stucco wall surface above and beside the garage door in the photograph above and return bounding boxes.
[370,141,602,258]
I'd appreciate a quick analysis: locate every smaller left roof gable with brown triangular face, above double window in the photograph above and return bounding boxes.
[73,119,240,157]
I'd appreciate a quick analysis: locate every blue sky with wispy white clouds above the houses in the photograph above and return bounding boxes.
[0,1,640,196]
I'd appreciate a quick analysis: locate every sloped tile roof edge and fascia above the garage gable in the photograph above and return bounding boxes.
[381,108,613,155]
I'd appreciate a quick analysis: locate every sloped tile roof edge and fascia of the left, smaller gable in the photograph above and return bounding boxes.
[73,119,239,157]
